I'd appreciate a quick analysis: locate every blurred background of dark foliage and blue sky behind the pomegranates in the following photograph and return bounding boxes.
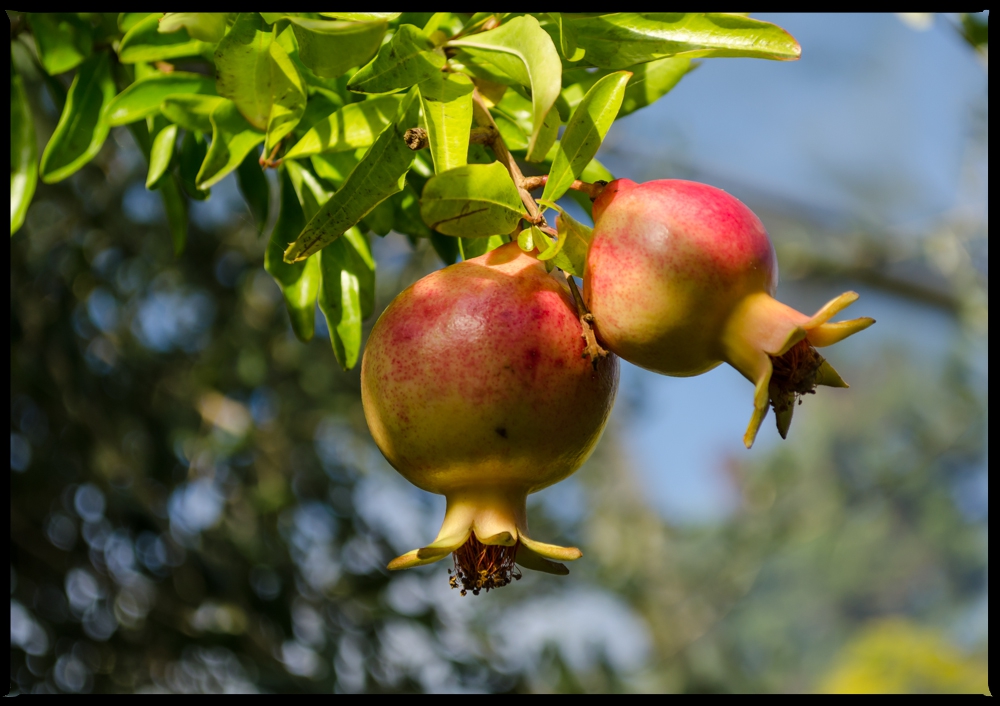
[10,15,989,693]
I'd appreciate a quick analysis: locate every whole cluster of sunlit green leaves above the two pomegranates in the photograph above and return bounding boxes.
[11,12,799,369]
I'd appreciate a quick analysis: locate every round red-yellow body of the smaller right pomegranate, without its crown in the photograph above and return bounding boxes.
[583,179,778,376]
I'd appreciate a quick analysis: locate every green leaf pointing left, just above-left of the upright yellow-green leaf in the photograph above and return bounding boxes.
[347,25,445,93]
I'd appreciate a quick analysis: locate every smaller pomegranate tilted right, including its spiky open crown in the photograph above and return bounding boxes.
[584,179,875,448]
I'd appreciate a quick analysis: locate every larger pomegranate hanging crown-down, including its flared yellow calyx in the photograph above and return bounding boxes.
[361,243,618,593]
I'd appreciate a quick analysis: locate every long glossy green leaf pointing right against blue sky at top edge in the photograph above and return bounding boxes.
[566,12,802,69]
